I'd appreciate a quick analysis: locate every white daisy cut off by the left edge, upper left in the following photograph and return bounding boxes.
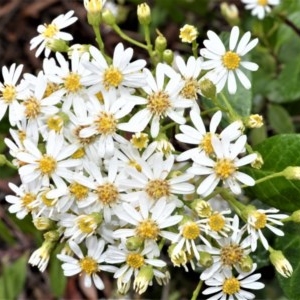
[0,64,23,126]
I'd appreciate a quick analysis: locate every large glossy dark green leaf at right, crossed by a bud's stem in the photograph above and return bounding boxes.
[245,134,300,211]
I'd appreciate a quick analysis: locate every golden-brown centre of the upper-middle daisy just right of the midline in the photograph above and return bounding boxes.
[147,91,171,116]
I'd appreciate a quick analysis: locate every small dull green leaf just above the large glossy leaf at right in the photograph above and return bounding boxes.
[268,104,295,133]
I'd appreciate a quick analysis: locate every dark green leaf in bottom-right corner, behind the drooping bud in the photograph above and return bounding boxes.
[275,223,300,300]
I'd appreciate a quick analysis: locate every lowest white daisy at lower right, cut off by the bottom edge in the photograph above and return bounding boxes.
[202,264,265,300]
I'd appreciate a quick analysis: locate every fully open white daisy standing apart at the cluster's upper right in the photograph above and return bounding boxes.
[200,26,258,94]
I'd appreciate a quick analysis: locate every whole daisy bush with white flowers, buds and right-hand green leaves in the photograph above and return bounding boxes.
[0,0,300,300]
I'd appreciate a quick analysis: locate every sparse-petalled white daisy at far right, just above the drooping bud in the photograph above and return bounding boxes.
[245,208,288,251]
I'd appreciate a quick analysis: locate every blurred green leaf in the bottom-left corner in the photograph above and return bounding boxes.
[0,253,28,299]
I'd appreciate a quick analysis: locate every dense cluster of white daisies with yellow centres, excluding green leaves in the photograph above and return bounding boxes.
[0,0,292,299]
